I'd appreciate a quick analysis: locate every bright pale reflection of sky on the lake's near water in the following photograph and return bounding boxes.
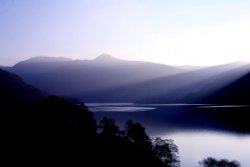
[161,131,250,167]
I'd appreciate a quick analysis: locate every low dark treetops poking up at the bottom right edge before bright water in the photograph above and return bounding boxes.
[199,157,241,167]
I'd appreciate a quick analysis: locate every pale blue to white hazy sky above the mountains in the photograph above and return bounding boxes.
[0,0,250,65]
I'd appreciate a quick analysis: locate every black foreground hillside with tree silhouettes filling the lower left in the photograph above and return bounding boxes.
[0,68,171,167]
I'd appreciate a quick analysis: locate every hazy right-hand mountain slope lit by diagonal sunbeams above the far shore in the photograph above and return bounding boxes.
[75,63,250,103]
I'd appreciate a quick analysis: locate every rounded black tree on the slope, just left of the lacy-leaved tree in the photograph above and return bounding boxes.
[125,120,152,150]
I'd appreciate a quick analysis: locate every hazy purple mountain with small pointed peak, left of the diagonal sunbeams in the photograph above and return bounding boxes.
[6,55,183,97]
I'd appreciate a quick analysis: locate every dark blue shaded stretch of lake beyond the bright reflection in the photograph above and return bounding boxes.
[86,103,250,134]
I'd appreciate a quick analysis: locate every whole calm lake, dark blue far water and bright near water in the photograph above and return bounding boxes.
[85,103,250,167]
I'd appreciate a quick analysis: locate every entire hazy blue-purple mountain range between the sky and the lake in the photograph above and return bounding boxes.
[4,54,250,103]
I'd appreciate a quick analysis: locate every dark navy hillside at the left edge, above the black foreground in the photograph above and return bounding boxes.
[0,69,48,104]
